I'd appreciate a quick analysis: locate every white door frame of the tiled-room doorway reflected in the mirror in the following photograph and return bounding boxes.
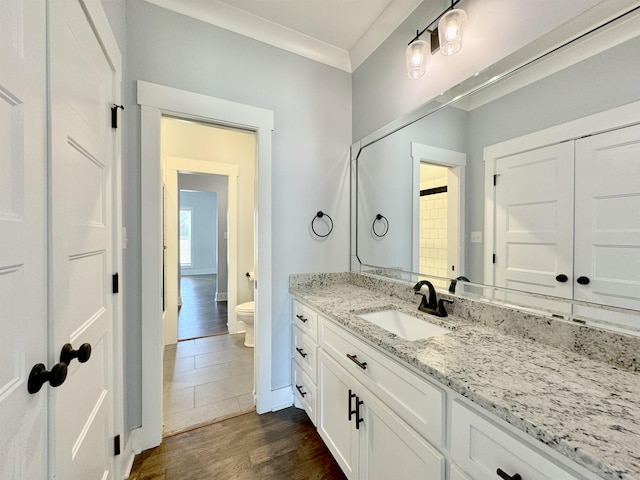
[411,142,467,277]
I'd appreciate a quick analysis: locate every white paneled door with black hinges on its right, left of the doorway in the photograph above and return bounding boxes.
[49,0,114,479]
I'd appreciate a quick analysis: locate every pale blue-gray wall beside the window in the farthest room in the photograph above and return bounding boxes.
[180,191,218,275]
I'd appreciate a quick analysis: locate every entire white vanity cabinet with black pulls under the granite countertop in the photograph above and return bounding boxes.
[292,300,599,480]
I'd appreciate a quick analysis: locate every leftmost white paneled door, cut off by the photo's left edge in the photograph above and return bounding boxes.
[0,2,51,480]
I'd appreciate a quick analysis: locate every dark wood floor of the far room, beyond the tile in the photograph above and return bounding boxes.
[178,275,229,340]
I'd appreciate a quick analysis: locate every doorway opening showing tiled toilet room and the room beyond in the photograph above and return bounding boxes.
[161,116,257,436]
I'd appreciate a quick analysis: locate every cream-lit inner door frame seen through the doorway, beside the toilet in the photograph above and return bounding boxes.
[164,157,239,345]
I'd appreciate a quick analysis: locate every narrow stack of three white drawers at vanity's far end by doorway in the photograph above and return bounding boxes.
[291,300,318,425]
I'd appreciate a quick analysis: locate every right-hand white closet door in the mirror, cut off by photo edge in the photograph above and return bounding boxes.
[574,125,640,316]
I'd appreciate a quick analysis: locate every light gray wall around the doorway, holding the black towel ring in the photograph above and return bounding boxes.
[123,0,351,427]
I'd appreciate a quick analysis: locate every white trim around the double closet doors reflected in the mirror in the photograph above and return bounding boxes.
[483,101,640,285]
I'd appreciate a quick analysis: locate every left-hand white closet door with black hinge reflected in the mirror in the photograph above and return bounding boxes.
[495,142,574,310]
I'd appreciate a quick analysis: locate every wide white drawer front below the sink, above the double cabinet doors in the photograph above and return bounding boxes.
[320,317,445,446]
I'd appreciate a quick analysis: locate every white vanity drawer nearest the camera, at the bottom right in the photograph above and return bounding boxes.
[451,400,579,480]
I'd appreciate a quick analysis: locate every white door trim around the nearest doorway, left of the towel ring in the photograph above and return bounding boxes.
[137,80,277,450]
